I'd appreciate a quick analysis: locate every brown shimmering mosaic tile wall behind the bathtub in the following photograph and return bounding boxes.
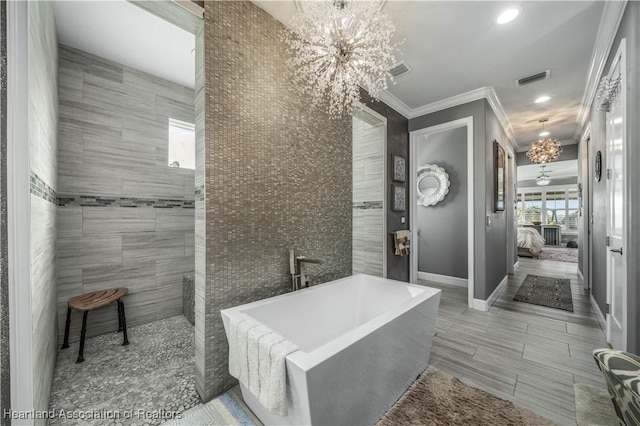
[196,1,352,400]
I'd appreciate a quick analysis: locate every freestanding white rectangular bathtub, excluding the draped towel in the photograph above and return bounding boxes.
[221,274,440,425]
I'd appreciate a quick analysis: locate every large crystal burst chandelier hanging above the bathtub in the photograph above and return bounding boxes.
[284,0,397,118]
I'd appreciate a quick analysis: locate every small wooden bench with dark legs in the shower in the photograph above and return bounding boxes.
[61,287,129,364]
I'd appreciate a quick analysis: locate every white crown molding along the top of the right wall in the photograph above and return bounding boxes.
[575,0,627,140]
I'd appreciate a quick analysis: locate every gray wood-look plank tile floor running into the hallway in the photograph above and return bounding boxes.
[421,258,607,425]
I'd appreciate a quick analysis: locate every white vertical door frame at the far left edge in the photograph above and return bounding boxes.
[3,1,34,411]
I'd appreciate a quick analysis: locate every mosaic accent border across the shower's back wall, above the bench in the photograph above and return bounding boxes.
[57,195,195,209]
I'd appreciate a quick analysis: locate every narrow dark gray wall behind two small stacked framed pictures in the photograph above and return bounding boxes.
[360,89,409,282]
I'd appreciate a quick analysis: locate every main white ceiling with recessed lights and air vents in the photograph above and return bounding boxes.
[253,0,605,151]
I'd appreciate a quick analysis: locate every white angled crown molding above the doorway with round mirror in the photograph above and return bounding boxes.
[378,86,520,151]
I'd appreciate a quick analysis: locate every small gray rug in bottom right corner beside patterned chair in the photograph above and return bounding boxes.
[573,383,618,426]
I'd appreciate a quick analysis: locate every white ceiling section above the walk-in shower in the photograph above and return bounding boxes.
[54,0,195,88]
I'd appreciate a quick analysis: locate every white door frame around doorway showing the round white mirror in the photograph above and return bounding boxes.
[407,116,475,308]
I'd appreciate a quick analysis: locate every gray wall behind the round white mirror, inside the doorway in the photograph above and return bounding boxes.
[412,126,468,278]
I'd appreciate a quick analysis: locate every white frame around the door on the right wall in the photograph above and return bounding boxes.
[605,38,630,351]
